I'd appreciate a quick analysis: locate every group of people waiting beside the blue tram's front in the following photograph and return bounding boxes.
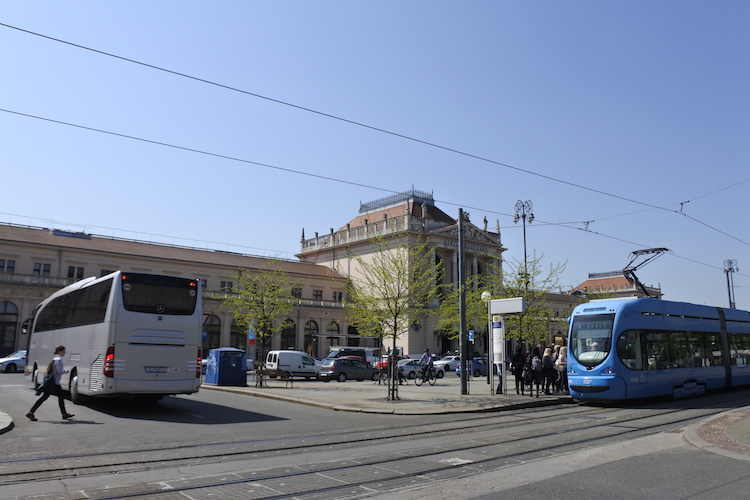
[510,344,568,397]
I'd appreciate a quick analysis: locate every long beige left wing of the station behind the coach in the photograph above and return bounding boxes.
[0,224,352,359]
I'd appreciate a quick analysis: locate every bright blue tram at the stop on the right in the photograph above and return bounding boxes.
[568,299,750,401]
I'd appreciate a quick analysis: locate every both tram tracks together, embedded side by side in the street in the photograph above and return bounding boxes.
[0,394,748,500]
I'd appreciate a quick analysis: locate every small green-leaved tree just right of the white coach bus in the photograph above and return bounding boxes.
[222,259,299,363]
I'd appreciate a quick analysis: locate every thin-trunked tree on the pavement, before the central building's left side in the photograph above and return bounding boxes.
[344,232,438,400]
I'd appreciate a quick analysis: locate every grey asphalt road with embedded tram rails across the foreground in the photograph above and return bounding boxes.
[0,374,750,500]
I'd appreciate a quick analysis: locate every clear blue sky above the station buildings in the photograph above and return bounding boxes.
[0,0,750,309]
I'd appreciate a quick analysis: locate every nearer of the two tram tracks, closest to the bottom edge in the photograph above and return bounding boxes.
[8,402,724,500]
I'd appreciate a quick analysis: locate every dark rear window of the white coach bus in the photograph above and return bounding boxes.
[122,273,198,315]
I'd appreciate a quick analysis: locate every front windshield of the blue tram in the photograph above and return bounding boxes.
[569,314,615,368]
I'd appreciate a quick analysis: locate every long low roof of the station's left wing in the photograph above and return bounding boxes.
[0,223,344,279]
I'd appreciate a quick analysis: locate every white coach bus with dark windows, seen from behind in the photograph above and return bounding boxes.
[25,271,202,403]
